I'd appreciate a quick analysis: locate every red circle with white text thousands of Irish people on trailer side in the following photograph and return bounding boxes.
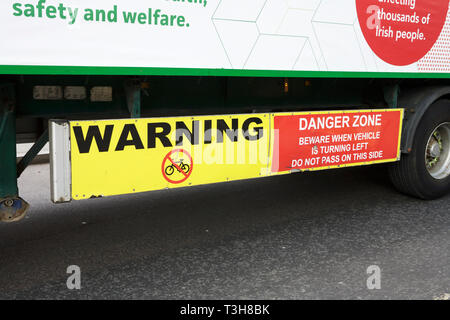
[356,0,449,66]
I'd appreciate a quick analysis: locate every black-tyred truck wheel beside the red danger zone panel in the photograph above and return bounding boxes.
[389,100,450,200]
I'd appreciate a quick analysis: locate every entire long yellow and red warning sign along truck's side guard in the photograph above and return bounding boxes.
[70,109,403,200]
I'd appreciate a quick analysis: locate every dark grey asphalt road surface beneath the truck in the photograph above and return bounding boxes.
[0,165,450,299]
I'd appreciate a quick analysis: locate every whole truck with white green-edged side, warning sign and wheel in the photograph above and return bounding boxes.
[0,0,450,222]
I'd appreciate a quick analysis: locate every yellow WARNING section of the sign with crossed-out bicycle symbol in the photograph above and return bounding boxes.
[70,114,270,200]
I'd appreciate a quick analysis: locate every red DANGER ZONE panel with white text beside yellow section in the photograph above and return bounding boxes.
[272,109,403,173]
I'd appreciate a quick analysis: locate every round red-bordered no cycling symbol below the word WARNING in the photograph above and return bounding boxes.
[161,149,194,184]
